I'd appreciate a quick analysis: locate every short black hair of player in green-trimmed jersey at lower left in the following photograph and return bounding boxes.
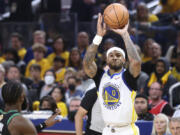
[2,81,23,105]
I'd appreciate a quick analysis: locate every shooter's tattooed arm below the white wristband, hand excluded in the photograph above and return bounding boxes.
[83,45,98,78]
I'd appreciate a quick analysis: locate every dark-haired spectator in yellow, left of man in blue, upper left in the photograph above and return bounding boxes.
[11,33,26,60]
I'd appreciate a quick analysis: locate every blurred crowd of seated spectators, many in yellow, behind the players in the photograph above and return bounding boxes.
[0,0,180,135]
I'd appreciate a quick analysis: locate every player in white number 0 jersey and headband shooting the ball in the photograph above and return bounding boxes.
[83,14,141,135]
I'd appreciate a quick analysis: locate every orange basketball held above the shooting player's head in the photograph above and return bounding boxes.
[103,3,129,29]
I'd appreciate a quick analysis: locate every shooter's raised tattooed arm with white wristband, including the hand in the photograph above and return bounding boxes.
[83,13,106,78]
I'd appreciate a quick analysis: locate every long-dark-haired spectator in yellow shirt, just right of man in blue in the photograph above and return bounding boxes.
[47,36,69,66]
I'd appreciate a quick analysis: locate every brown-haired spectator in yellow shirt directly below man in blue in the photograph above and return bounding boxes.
[25,43,51,78]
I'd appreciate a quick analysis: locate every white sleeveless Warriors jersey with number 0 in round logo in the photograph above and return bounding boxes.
[98,69,137,125]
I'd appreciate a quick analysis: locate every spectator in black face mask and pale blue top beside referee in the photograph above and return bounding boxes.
[65,76,83,105]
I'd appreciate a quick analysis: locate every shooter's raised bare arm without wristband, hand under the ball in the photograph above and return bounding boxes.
[112,23,141,77]
